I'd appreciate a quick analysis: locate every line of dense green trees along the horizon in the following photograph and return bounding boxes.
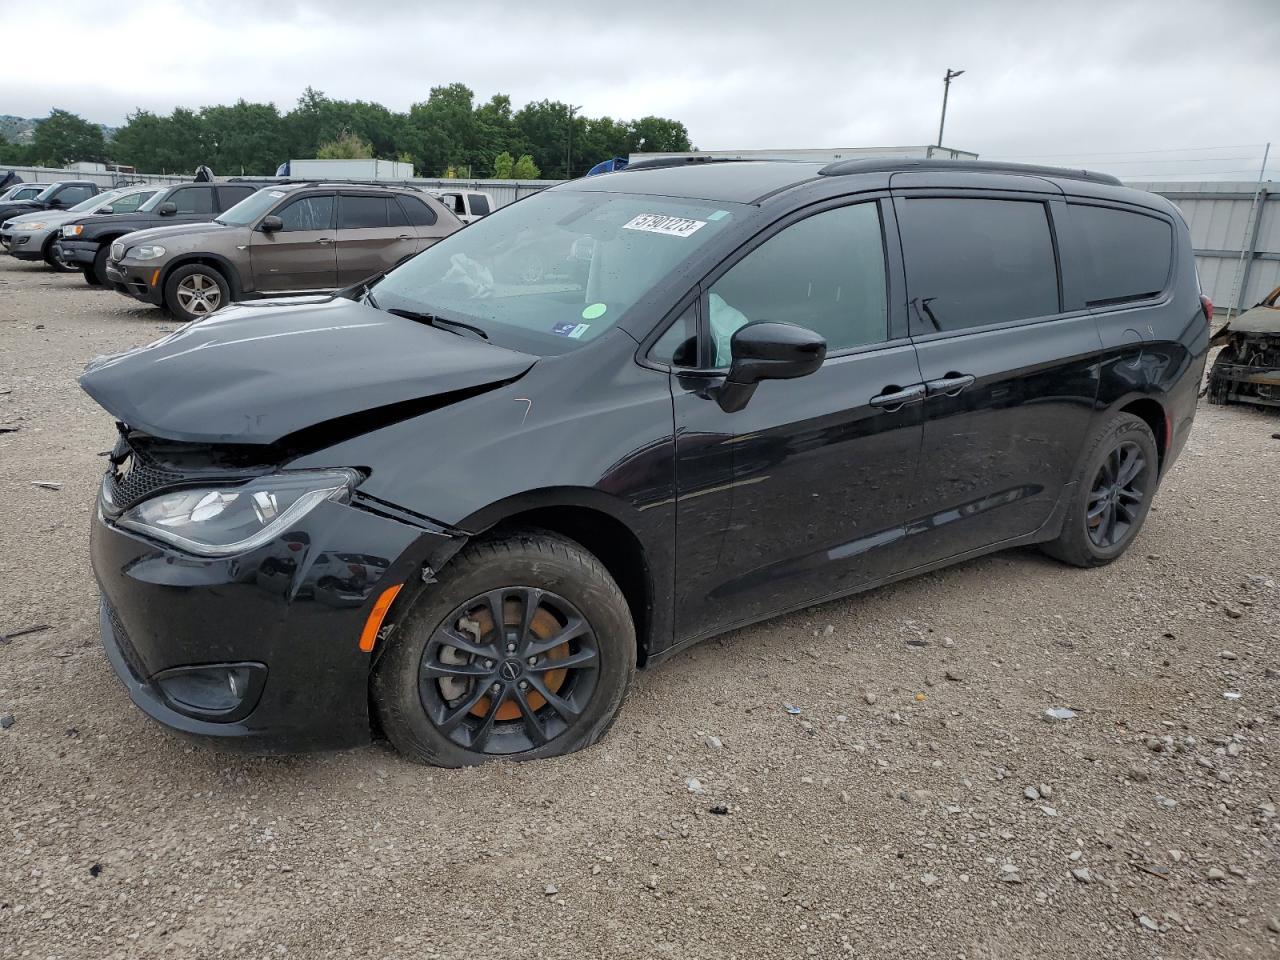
[0,83,691,179]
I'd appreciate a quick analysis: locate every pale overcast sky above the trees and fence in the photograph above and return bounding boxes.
[12,0,1280,179]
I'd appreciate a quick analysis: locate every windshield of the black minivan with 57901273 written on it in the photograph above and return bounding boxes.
[372,191,742,355]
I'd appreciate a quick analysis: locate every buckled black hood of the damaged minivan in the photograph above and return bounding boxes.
[79,297,538,447]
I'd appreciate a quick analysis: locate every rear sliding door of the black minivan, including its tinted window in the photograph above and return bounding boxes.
[893,192,1101,566]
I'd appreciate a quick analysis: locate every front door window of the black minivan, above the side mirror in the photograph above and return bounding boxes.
[709,204,888,367]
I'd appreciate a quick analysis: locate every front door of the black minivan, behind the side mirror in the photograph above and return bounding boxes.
[672,200,922,640]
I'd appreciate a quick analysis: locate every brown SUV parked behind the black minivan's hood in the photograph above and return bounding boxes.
[106,183,462,320]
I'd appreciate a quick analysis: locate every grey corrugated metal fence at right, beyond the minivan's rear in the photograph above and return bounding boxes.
[1128,180,1280,315]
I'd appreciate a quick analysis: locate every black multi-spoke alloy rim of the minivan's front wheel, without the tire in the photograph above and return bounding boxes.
[419,586,600,754]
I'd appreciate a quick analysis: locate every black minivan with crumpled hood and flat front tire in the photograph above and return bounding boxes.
[81,160,1211,765]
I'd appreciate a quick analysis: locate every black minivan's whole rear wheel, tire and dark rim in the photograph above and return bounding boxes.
[1041,413,1160,567]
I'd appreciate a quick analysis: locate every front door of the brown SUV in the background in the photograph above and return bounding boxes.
[250,193,338,293]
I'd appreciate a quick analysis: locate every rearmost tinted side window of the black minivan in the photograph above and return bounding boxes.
[1069,204,1174,307]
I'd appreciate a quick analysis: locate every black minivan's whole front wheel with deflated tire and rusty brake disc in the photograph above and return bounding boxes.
[371,530,636,767]
